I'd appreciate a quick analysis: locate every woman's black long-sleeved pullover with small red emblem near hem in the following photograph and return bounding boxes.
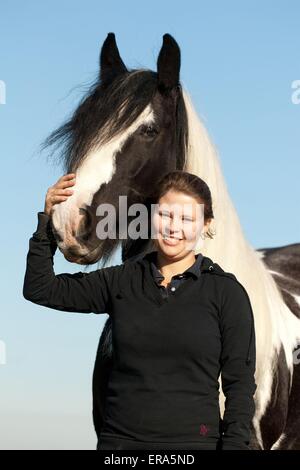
[23,213,256,450]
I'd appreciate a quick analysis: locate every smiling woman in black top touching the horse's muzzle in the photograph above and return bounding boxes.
[23,171,256,450]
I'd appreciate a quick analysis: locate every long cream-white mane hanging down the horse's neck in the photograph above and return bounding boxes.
[183,87,300,444]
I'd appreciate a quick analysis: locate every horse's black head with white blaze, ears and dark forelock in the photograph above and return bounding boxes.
[46,33,187,264]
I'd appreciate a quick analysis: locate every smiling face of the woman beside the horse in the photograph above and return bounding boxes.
[153,190,210,258]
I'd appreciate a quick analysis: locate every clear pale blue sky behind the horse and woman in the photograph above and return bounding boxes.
[0,0,300,449]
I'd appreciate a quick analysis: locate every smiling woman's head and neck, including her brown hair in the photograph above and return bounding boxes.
[146,170,214,284]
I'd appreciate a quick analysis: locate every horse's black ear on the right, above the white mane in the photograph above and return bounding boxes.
[157,34,180,92]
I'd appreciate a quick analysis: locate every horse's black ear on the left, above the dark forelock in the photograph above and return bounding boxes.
[100,33,127,82]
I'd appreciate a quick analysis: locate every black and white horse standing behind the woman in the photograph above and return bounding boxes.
[44,33,300,450]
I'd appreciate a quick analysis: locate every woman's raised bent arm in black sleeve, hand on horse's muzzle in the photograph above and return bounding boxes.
[23,175,122,313]
